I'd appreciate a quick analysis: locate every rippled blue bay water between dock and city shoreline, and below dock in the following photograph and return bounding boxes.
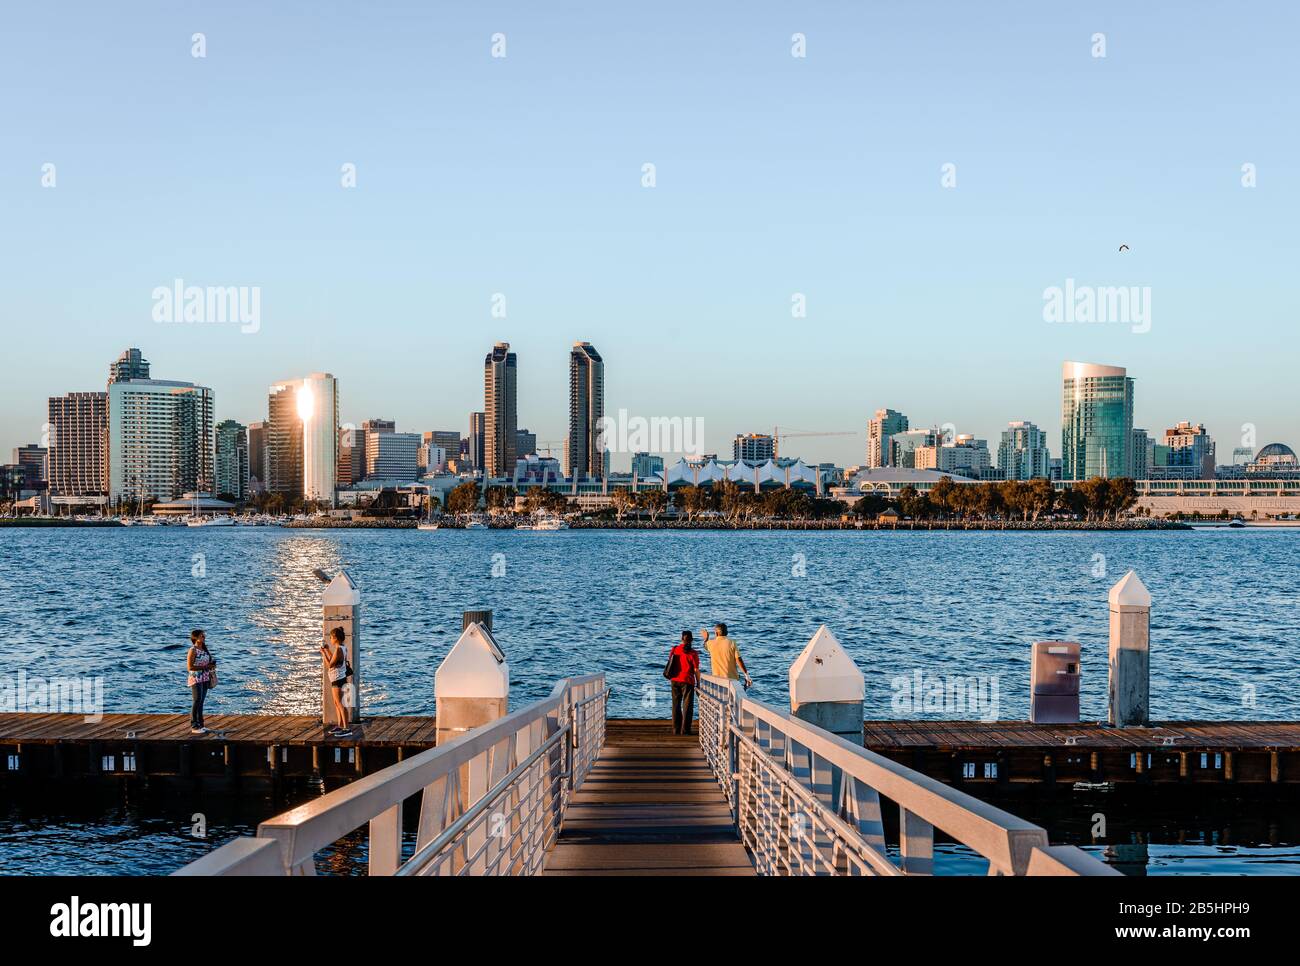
[0,528,1300,872]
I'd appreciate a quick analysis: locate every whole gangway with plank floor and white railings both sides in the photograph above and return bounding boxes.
[165,673,1117,876]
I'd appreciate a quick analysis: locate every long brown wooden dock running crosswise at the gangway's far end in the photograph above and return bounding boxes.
[0,714,1300,790]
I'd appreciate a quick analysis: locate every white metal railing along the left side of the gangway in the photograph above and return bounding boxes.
[176,673,610,875]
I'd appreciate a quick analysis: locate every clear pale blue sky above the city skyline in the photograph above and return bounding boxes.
[0,0,1300,465]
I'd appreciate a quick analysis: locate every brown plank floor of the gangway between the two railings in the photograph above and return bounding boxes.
[546,719,755,875]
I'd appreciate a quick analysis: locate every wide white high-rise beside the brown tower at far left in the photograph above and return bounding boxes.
[108,380,216,502]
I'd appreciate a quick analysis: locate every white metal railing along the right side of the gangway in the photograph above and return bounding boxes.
[698,675,1119,875]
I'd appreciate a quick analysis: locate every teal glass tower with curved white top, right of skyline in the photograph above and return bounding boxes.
[1061,363,1134,480]
